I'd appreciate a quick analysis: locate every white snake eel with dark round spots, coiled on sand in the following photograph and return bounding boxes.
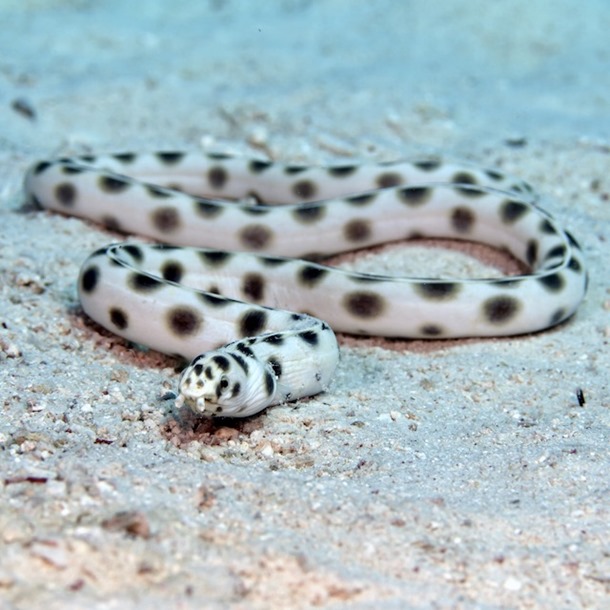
[25,152,587,417]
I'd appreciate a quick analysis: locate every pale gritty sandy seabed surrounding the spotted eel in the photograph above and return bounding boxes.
[0,0,610,610]
